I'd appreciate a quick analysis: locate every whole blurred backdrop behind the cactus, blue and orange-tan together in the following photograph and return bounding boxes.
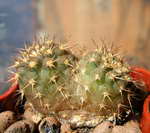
[0,0,150,83]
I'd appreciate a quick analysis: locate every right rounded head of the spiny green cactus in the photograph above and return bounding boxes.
[75,46,144,118]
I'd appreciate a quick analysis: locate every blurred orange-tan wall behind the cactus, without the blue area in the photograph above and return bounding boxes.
[35,0,150,68]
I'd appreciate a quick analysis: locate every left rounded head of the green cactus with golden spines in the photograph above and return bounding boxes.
[12,38,77,114]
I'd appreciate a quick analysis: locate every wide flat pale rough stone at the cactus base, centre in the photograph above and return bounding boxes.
[58,110,104,129]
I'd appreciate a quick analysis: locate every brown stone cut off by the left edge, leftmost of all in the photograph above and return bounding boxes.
[0,111,16,133]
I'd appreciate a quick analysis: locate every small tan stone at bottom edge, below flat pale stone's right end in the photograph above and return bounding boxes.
[93,121,112,133]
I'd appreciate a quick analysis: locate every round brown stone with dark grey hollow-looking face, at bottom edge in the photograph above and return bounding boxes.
[39,117,61,133]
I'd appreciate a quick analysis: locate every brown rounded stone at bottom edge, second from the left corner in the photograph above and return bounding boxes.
[4,120,35,133]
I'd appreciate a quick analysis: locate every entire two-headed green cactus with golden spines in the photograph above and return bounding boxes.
[13,39,144,122]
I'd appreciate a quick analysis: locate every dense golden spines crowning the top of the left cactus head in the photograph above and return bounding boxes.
[11,40,73,68]
